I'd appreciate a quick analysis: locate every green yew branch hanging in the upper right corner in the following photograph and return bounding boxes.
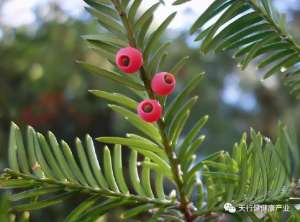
[191,0,300,98]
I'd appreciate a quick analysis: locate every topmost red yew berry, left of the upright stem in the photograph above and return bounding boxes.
[116,47,143,73]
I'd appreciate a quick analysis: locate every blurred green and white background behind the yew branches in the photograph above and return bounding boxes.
[0,0,300,222]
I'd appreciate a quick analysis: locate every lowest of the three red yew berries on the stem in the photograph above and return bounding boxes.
[137,99,162,123]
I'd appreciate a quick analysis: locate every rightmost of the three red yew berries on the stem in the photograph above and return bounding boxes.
[151,72,176,96]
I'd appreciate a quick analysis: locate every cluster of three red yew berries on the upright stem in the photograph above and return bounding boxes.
[116,47,176,123]
